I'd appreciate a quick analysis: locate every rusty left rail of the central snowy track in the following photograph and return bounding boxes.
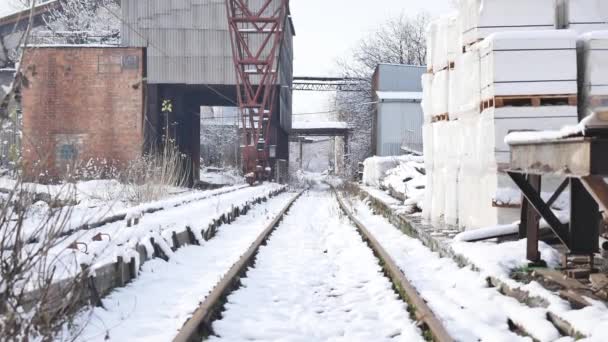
[173,191,304,342]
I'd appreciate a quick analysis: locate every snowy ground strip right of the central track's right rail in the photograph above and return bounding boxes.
[347,190,608,342]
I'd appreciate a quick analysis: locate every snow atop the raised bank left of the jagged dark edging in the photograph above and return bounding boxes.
[21,183,282,288]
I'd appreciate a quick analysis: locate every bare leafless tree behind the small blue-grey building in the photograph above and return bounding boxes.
[336,14,429,176]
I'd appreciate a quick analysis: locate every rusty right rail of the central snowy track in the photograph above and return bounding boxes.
[332,187,454,342]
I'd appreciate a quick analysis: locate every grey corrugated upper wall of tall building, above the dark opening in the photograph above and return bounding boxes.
[121,0,294,130]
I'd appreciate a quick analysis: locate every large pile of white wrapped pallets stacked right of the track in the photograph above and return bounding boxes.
[423,0,608,229]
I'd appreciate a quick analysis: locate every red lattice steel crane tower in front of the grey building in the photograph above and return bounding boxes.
[225,0,289,184]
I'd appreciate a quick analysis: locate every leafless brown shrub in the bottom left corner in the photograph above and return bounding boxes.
[0,182,95,341]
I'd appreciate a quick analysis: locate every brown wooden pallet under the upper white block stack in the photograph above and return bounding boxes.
[480,95,578,111]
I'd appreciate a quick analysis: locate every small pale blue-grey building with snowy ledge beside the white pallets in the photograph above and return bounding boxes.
[372,64,425,156]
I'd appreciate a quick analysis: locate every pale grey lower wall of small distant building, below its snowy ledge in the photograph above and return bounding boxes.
[376,102,423,156]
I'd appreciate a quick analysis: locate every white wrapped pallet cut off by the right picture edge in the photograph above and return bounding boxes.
[578,31,608,128]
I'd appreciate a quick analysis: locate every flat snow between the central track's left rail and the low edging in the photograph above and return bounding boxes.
[70,192,295,342]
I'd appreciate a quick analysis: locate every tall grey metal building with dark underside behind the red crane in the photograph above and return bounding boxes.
[121,0,295,179]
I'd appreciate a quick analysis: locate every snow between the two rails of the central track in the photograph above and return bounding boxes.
[210,191,423,341]
